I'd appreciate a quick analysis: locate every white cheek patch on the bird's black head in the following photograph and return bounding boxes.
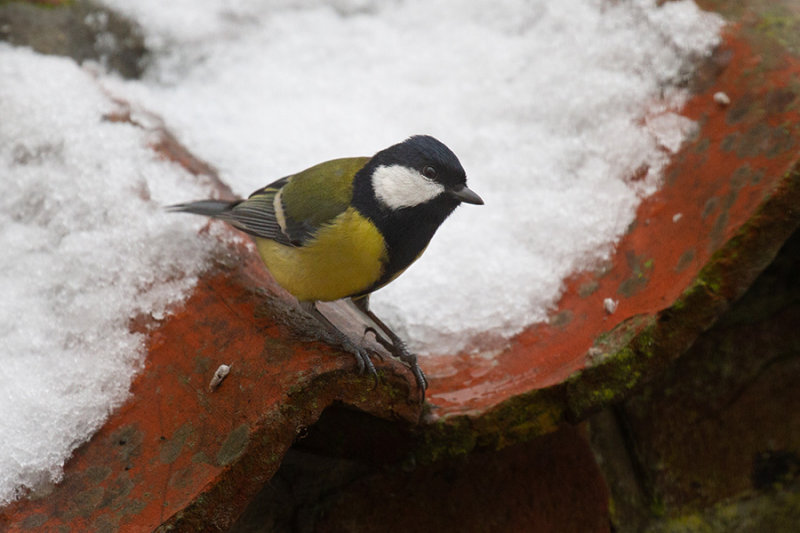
[372,165,444,209]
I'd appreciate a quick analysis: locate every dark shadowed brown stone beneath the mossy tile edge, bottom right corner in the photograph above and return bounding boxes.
[590,231,800,533]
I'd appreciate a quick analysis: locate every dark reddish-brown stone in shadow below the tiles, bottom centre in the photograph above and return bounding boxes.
[232,426,610,533]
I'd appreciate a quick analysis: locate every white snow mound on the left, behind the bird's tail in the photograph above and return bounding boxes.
[0,44,218,503]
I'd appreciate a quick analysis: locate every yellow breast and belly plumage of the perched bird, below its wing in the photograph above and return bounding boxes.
[256,207,387,301]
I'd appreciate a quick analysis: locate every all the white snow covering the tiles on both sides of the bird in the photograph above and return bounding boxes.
[0,0,722,503]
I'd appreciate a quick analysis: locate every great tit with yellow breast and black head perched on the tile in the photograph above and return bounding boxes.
[168,135,483,398]
